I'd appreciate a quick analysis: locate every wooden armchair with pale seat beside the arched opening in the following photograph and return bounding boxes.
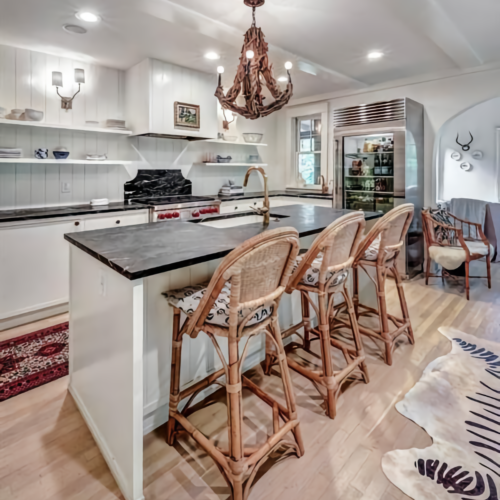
[422,209,491,300]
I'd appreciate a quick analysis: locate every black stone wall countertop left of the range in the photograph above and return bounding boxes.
[0,202,148,224]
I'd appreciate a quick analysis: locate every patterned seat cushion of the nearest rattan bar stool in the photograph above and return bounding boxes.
[163,282,274,328]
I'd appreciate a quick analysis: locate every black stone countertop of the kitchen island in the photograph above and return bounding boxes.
[64,205,383,280]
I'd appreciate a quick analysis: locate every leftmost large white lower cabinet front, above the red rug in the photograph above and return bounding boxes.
[0,219,82,320]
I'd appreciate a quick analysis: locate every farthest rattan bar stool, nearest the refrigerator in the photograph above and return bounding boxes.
[353,203,415,365]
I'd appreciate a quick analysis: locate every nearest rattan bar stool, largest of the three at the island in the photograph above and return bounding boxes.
[164,228,304,500]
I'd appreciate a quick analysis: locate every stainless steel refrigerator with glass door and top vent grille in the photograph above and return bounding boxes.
[334,98,424,278]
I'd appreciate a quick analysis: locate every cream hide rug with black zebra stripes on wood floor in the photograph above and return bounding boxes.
[382,328,500,500]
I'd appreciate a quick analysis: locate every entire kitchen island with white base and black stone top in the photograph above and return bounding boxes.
[65,205,382,500]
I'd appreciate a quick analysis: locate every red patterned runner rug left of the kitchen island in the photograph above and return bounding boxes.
[0,323,69,401]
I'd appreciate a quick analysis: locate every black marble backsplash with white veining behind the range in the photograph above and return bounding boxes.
[124,170,193,201]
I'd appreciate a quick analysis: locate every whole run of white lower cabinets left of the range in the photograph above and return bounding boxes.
[0,210,149,330]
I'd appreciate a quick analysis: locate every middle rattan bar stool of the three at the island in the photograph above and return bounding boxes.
[264,212,369,418]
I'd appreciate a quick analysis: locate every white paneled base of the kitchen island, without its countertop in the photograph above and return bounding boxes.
[70,229,378,500]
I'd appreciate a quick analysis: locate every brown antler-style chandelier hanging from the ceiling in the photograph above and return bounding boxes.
[215,0,293,120]
